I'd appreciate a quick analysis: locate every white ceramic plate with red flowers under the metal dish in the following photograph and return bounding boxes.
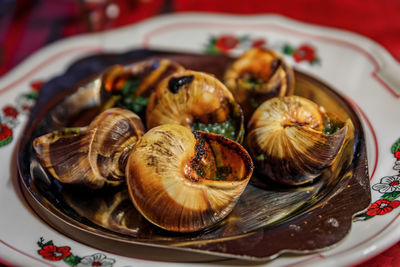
[0,13,400,266]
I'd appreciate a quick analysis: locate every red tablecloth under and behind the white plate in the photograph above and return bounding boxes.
[0,0,400,266]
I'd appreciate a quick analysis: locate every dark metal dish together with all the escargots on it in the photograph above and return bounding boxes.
[17,49,370,264]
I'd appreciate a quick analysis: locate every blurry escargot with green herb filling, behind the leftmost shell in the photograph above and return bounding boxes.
[102,59,184,115]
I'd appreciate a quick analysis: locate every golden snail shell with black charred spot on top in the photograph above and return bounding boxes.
[146,70,244,142]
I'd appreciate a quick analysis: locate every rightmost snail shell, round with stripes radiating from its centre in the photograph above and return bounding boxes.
[246,96,348,185]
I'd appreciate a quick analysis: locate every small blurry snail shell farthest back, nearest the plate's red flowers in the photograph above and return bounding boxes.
[224,48,295,121]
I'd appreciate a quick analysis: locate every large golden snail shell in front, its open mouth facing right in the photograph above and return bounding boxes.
[126,124,253,232]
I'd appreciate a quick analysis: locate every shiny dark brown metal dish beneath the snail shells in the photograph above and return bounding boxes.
[18,50,370,260]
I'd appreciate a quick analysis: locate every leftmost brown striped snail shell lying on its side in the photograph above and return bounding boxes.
[33,108,144,189]
